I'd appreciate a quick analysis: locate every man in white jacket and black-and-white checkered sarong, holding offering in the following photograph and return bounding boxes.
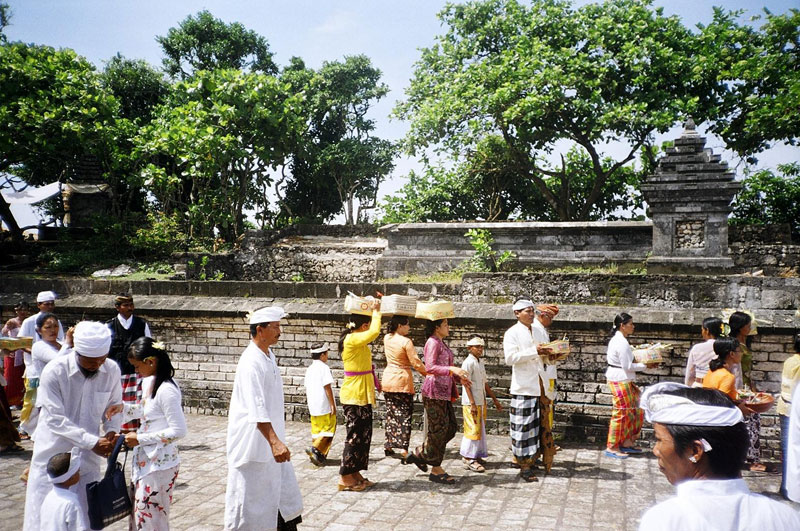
[503,299,555,482]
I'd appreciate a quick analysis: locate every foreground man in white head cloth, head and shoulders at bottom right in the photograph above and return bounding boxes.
[639,382,800,531]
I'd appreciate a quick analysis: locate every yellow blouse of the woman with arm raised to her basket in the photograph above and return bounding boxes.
[339,310,381,406]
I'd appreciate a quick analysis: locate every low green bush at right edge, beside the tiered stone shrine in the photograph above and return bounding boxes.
[731,162,800,236]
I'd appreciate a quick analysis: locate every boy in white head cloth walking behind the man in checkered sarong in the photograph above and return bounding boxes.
[461,336,503,472]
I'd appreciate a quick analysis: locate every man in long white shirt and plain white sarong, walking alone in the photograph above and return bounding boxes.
[225,306,303,531]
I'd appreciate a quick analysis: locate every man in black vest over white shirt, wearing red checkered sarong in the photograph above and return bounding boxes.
[106,293,153,433]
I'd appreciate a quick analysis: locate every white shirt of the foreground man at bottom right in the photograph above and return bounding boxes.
[639,478,800,531]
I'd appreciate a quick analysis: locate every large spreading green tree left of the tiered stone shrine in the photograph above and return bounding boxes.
[395,0,709,221]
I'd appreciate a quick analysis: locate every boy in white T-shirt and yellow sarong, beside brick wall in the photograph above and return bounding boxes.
[305,343,336,466]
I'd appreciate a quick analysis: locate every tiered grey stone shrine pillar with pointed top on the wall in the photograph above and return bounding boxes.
[641,118,741,273]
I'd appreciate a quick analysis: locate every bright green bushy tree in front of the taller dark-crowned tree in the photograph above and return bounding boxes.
[137,70,301,242]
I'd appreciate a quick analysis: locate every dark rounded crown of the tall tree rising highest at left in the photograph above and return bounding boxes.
[156,10,278,79]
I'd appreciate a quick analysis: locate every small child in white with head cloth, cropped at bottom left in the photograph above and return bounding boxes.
[39,448,89,531]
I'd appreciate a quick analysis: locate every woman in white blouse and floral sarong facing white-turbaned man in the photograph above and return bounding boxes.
[124,337,186,531]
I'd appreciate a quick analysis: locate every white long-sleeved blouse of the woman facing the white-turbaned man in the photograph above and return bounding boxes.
[122,376,187,481]
